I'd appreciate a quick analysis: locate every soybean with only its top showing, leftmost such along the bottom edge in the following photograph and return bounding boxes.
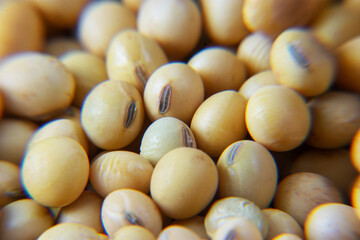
[38,223,105,240]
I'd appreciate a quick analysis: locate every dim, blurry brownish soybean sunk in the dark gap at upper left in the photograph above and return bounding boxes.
[44,36,82,57]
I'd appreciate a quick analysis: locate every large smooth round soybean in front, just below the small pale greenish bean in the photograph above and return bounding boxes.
[150,147,218,219]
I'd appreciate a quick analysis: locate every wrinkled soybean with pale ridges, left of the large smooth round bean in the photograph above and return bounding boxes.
[90,150,153,197]
